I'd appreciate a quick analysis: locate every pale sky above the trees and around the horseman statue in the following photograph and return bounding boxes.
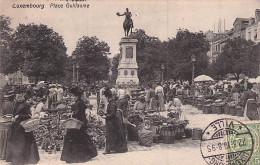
[0,0,260,57]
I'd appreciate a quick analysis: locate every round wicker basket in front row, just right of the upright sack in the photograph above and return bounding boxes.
[160,125,176,144]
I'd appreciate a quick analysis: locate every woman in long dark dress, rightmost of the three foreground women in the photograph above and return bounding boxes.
[104,88,128,154]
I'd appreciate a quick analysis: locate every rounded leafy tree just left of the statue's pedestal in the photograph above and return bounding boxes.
[72,36,110,83]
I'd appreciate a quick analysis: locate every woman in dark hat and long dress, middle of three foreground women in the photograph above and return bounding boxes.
[61,87,98,163]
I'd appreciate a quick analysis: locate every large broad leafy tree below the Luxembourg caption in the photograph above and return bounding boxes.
[10,24,67,82]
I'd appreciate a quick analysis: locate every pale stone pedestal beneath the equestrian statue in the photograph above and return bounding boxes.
[116,37,139,84]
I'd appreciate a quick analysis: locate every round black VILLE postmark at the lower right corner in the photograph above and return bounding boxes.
[200,118,255,165]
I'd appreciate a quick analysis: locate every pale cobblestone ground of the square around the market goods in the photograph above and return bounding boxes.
[0,96,243,165]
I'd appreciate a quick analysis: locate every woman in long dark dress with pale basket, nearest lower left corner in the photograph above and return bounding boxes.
[6,94,40,165]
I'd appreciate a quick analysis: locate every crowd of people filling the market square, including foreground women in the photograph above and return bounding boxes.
[0,78,260,164]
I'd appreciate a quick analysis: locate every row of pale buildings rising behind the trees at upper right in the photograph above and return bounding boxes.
[205,9,260,64]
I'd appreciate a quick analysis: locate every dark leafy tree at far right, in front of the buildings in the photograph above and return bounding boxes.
[215,38,260,81]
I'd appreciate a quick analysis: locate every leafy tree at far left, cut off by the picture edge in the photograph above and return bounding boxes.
[0,15,13,74]
